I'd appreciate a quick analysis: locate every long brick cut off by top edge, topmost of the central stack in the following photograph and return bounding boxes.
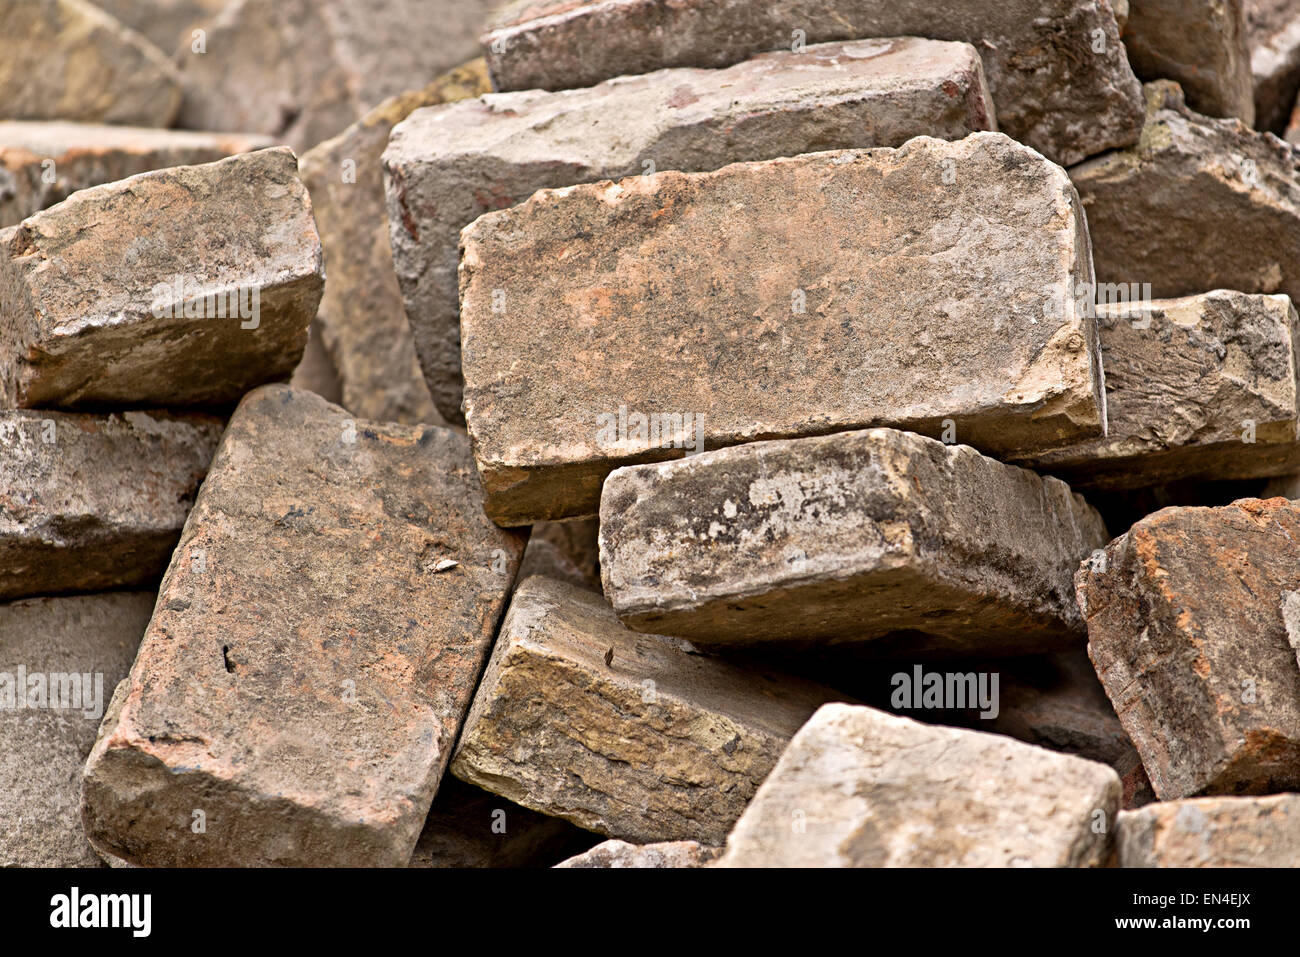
[484,0,1141,164]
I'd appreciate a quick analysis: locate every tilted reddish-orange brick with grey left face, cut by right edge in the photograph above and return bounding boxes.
[1078,498,1300,801]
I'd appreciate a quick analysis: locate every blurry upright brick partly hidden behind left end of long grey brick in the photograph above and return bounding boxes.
[299,60,491,425]
